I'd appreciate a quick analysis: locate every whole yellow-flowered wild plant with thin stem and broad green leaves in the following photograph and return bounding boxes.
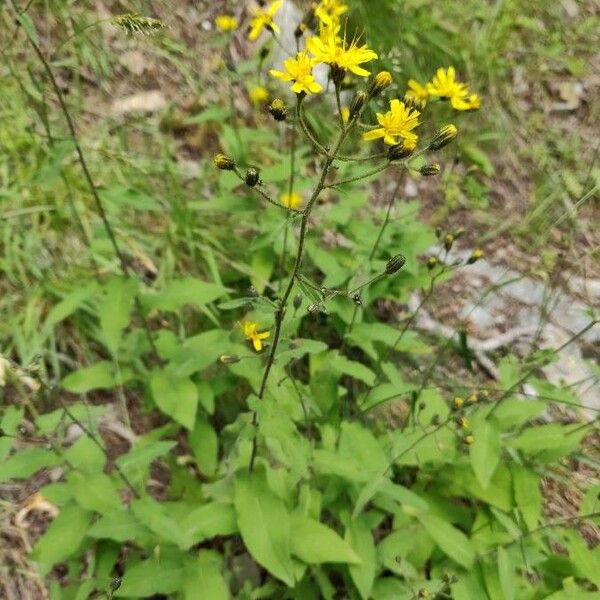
[0,0,600,600]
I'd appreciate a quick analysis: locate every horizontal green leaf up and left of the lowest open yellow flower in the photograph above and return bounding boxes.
[142,277,228,312]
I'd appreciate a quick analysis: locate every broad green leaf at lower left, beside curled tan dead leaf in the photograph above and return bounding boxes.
[32,505,92,575]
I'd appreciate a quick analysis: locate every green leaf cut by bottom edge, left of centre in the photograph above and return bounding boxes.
[115,558,184,598]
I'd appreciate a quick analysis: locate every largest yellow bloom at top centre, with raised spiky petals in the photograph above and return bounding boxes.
[306,27,377,77]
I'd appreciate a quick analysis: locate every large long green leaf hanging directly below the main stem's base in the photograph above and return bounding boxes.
[234,471,294,587]
